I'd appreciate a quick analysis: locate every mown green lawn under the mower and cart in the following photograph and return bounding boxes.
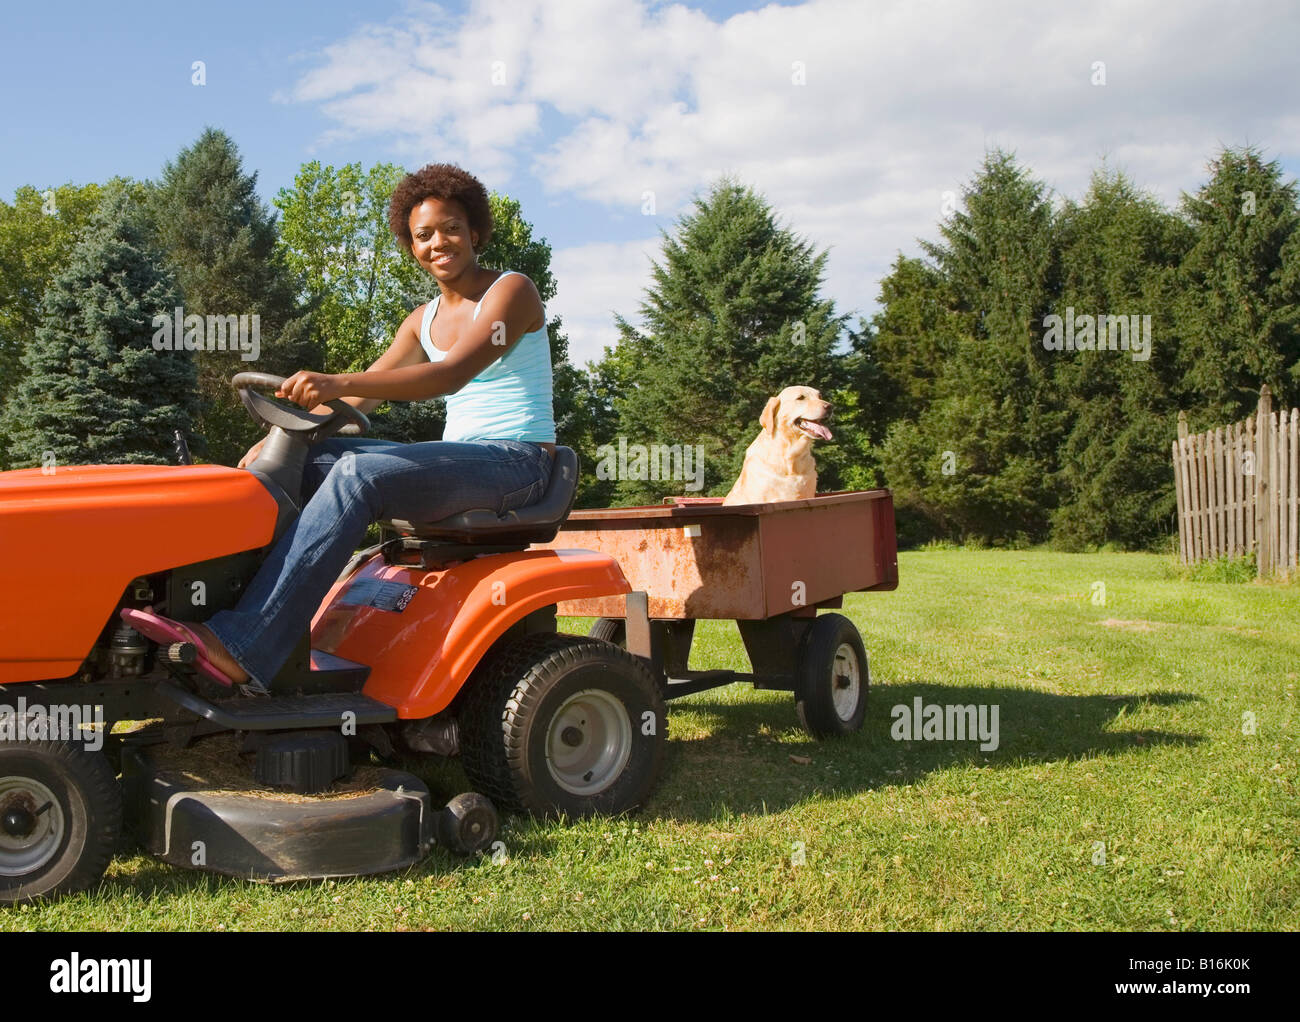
[0,550,1300,930]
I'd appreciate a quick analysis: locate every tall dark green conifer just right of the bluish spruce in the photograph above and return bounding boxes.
[150,127,320,465]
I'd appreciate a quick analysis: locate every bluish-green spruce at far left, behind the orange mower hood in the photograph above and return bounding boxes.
[0,189,198,467]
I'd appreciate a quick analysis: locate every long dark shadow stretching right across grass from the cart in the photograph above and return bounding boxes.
[647,685,1203,822]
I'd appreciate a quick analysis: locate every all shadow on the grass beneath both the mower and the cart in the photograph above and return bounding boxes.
[100,685,1203,898]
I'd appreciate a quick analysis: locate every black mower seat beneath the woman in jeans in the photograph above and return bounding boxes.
[378,447,577,549]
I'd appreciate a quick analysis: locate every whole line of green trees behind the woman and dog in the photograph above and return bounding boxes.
[0,129,1300,549]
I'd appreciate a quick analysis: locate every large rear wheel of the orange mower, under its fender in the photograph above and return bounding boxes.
[460,635,667,818]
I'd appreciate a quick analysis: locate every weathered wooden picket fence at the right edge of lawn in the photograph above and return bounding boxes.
[1173,384,1300,577]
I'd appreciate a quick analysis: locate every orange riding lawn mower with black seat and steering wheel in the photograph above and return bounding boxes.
[0,373,667,902]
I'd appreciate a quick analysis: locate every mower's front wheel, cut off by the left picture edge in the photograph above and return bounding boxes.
[0,741,122,904]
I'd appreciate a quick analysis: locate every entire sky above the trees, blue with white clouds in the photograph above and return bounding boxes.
[0,0,1300,361]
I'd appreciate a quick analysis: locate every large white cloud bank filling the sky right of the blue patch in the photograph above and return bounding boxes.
[290,0,1300,360]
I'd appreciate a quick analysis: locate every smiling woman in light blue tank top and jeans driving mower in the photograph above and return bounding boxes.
[130,164,555,693]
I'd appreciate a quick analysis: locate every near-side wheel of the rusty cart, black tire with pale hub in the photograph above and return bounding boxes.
[794,614,871,739]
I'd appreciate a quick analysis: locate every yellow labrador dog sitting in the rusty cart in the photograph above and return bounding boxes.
[723,386,831,504]
